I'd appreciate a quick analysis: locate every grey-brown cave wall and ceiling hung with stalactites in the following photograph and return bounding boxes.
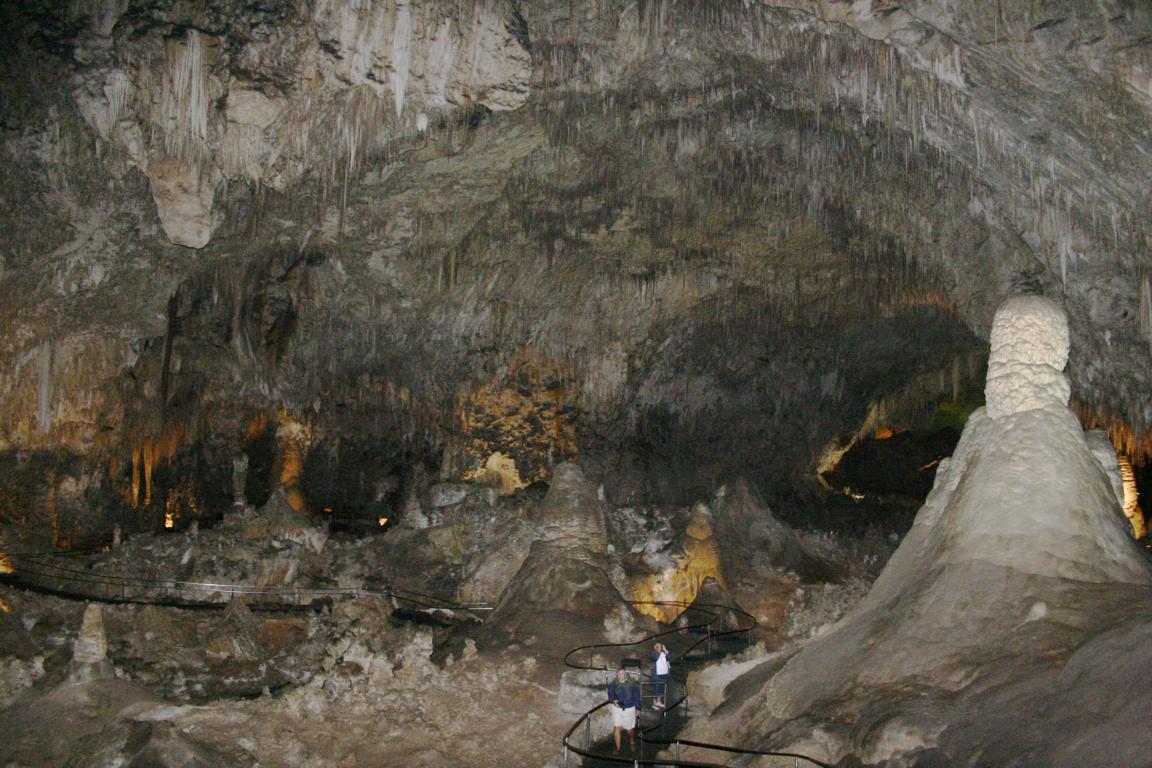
[0,0,1152,559]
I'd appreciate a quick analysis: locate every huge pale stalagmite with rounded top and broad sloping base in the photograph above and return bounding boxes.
[681,296,1152,766]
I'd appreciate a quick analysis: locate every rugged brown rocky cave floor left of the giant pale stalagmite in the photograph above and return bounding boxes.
[0,465,870,767]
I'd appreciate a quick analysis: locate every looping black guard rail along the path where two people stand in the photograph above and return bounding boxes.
[563,601,832,768]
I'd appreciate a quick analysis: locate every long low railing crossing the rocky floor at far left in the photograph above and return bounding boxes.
[0,552,487,610]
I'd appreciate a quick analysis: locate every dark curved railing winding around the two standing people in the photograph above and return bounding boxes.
[562,601,831,768]
